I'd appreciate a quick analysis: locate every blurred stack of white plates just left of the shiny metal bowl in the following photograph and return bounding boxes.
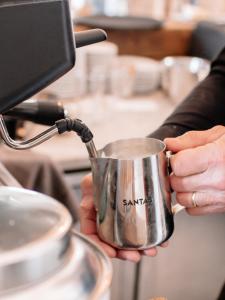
[111,55,162,96]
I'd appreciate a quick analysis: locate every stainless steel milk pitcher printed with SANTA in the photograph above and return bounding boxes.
[90,138,183,249]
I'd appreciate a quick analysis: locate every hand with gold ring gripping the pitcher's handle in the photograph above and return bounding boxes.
[165,126,225,215]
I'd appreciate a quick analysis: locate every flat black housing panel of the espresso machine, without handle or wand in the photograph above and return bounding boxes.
[0,0,75,114]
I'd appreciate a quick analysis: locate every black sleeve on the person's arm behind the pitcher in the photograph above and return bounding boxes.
[149,48,225,139]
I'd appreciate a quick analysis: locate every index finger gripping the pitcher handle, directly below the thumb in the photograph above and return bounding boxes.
[170,143,217,177]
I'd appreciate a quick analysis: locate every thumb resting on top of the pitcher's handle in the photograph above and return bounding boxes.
[164,126,225,152]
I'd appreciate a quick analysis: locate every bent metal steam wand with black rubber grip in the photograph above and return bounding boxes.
[0,115,97,157]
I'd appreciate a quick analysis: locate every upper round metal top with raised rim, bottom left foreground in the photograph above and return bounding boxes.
[0,187,72,295]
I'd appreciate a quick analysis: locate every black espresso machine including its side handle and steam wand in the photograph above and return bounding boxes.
[0,0,103,154]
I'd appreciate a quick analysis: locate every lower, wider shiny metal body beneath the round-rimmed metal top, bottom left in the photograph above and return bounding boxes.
[0,232,112,300]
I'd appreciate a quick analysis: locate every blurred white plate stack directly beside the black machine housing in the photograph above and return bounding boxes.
[44,42,118,99]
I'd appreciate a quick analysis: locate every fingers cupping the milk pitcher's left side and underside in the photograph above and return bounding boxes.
[80,174,168,262]
